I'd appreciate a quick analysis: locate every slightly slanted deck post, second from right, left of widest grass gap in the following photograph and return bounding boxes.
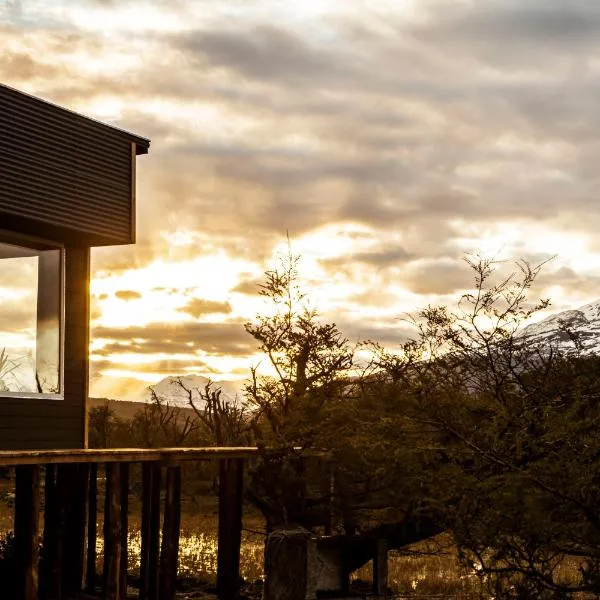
[159,466,181,600]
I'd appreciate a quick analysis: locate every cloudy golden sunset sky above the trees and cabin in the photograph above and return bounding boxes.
[0,0,600,396]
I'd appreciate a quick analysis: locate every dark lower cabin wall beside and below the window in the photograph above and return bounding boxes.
[0,246,90,450]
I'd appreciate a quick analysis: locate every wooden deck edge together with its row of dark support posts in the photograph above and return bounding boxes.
[0,447,257,600]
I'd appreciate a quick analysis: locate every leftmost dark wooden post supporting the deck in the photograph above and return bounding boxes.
[14,465,40,600]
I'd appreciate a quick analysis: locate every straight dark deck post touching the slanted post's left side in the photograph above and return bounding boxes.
[139,463,160,600]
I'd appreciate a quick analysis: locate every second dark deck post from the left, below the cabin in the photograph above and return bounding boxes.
[40,465,62,598]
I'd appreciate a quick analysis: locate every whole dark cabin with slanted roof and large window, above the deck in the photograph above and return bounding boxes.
[0,85,150,450]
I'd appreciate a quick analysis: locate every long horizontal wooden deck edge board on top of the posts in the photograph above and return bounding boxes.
[0,446,258,467]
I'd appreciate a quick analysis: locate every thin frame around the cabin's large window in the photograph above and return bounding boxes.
[0,228,66,402]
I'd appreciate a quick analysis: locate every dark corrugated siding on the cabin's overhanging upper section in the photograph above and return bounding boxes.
[0,86,147,244]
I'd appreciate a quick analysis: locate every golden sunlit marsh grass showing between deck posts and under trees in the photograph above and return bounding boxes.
[0,486,585,600]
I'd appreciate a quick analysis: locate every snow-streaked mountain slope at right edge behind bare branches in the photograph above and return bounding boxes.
[521,300,600,354]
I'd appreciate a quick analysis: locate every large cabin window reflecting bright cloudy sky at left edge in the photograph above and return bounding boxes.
[0,232,63,397]
